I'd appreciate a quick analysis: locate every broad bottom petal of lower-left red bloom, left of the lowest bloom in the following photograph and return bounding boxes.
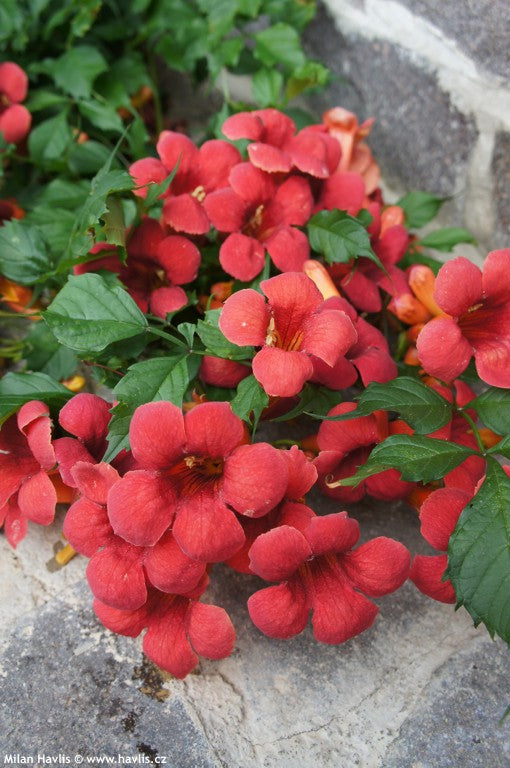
[86,539,147,611]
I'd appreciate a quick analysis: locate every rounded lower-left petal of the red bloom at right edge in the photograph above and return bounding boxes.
[416,316,474,381]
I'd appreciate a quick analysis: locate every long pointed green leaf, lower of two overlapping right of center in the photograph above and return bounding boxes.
[338,435,476,486]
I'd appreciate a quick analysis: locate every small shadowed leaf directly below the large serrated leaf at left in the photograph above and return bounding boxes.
[25,323,78,381]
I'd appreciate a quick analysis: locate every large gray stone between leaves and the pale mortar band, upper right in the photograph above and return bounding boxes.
[306,3,477,201]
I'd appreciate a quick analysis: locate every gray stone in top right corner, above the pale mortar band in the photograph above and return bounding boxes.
[400,0,510,80]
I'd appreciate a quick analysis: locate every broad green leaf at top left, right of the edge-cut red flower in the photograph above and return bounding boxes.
[45,45,108,99]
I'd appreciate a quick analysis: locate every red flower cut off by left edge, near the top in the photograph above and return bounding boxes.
[0,61,32,144]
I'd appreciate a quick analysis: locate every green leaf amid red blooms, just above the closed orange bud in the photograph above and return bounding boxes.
[308,209,384,270]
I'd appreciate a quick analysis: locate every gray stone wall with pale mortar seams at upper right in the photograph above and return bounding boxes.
[306,0,510,258]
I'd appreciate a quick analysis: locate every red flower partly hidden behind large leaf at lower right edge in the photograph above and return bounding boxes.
[409,488,473,603]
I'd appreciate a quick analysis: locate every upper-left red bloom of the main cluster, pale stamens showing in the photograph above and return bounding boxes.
[129,131,241,235]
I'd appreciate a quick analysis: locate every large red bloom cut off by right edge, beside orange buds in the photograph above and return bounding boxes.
[417,249,510,387]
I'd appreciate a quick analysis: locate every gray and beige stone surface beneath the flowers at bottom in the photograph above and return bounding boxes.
[0,498,510,768]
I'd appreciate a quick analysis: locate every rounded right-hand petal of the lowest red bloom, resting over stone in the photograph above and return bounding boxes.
[187,602,236,659]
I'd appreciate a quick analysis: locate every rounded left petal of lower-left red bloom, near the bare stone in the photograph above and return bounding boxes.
[63,498,113,557]
